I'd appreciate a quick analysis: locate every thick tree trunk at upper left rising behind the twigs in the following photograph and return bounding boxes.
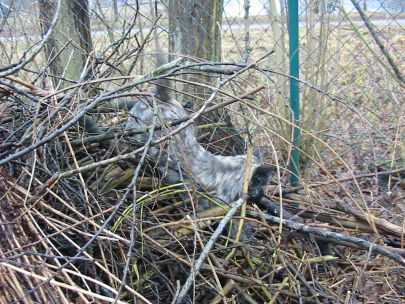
[39,0,93,87]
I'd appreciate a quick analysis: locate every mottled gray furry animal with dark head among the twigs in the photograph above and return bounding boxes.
[126,57,271,203]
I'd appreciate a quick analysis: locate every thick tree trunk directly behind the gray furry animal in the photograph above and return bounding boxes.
[169,0,243,154]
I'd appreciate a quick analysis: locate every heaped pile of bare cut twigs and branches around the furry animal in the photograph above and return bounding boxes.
[0,56,405,303]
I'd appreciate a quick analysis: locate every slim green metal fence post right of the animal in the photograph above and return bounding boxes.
[288,0,300,186]
